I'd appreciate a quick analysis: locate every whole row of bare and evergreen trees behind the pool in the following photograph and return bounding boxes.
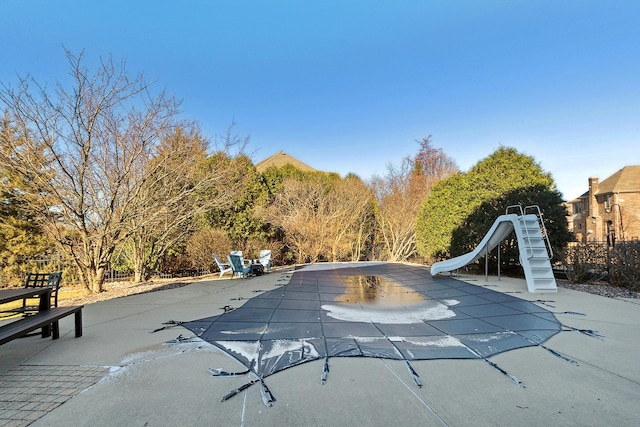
[0,51,571,292]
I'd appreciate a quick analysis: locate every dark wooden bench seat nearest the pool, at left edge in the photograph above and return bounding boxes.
[0,305,84,345]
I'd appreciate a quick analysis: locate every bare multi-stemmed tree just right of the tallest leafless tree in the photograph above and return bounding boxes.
[116,125,246,282]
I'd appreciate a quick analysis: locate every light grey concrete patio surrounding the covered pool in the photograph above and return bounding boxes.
[0,269,640,426]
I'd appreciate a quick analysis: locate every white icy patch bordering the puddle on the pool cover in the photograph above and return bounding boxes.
[322,301,456,325]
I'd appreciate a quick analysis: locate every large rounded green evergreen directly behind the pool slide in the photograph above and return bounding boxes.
[417,147,571,259]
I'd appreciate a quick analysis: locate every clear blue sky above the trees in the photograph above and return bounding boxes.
[0,0,640,199]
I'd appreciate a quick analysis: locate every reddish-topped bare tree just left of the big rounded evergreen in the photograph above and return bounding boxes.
[371,135,458,261]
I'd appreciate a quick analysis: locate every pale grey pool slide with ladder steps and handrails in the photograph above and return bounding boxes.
[431,211,558,292]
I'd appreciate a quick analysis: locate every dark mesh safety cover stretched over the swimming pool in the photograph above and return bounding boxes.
[182,262,562,396]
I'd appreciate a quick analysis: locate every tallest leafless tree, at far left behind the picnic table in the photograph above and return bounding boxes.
[0,51,192,292]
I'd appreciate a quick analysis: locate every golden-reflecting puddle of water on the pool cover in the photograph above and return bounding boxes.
[335,276,424,307]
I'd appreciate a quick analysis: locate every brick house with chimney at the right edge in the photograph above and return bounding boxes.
[567,165,640,244]
